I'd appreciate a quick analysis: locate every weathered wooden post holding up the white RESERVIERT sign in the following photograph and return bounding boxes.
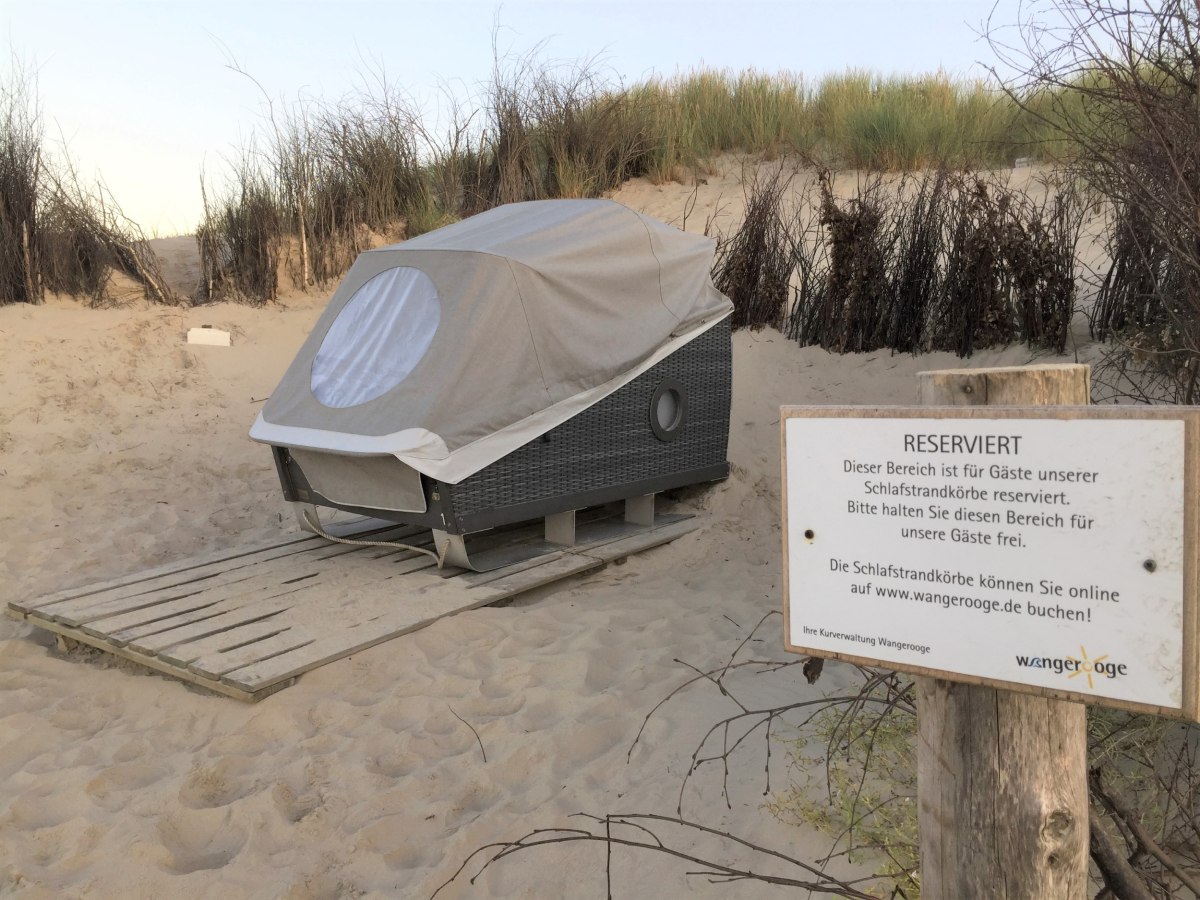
[917,365,1091,900]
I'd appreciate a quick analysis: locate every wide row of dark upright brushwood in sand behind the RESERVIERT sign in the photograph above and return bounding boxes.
[787,170,1081,356]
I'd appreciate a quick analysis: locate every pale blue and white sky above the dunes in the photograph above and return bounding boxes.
[0,0,1019,235]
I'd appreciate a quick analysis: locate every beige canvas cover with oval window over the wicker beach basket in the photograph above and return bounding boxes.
[251,200,732,484]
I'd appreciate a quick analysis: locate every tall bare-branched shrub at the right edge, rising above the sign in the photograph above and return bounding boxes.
[991,0,1200,403]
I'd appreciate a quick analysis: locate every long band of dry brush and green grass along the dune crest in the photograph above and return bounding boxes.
[200,56,1060,307]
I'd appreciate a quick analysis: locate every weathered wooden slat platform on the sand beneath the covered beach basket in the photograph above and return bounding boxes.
[6,516,700,701]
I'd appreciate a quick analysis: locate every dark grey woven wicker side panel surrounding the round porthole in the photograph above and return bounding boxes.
[449,319,732,516]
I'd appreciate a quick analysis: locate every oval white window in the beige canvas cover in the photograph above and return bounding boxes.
[312,266,442,409]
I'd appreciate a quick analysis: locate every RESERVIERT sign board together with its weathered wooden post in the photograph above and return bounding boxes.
[782,366,1200,900]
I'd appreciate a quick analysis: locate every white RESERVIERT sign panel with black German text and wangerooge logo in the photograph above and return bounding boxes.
[784,410,1184,708]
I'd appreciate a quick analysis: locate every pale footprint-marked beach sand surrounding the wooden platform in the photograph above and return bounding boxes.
[0,162,1093,900]
